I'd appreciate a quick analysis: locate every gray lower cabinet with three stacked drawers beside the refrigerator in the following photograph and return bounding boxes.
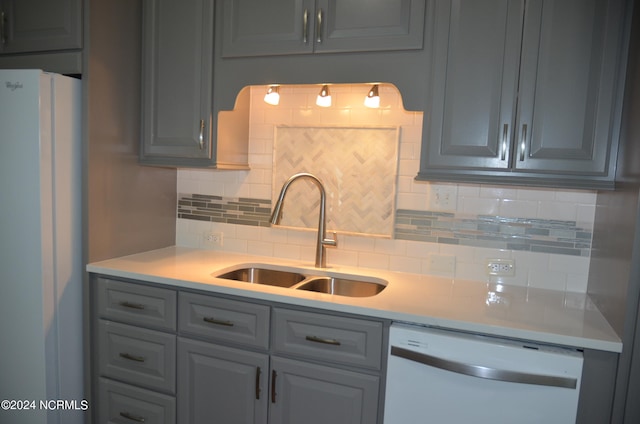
[91,275,177,424]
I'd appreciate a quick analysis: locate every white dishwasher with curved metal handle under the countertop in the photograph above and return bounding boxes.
[384,324,583,424]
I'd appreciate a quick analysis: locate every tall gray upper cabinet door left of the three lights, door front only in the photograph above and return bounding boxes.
[141,0,214,163]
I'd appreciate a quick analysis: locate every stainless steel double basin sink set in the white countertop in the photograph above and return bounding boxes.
[213,265,387,297]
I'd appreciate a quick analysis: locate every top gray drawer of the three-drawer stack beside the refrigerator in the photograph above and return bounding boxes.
[96,277,176,331]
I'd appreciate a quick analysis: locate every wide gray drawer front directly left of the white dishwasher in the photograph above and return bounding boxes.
[272,308,382,370]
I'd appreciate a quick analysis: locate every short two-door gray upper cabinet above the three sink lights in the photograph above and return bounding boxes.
[223,0,425,57]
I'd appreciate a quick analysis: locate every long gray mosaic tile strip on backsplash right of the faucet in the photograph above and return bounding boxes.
[394,210,592,256]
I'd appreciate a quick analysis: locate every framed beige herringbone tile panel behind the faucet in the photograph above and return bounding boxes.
[272,126,399,238]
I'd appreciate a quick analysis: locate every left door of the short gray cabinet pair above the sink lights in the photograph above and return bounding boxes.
[222,0,315,57]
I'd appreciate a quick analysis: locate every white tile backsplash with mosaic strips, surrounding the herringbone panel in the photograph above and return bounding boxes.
[176,84,596,292]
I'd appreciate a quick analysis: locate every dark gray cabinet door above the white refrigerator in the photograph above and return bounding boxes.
[0,0,82,54]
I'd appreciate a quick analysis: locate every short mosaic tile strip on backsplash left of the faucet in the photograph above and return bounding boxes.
[178,194,271,227]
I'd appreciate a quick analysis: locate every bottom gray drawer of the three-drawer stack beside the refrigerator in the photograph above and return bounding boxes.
[98,378,176,424]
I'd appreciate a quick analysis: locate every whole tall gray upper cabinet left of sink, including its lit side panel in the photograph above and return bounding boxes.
[140,0,249,169]
